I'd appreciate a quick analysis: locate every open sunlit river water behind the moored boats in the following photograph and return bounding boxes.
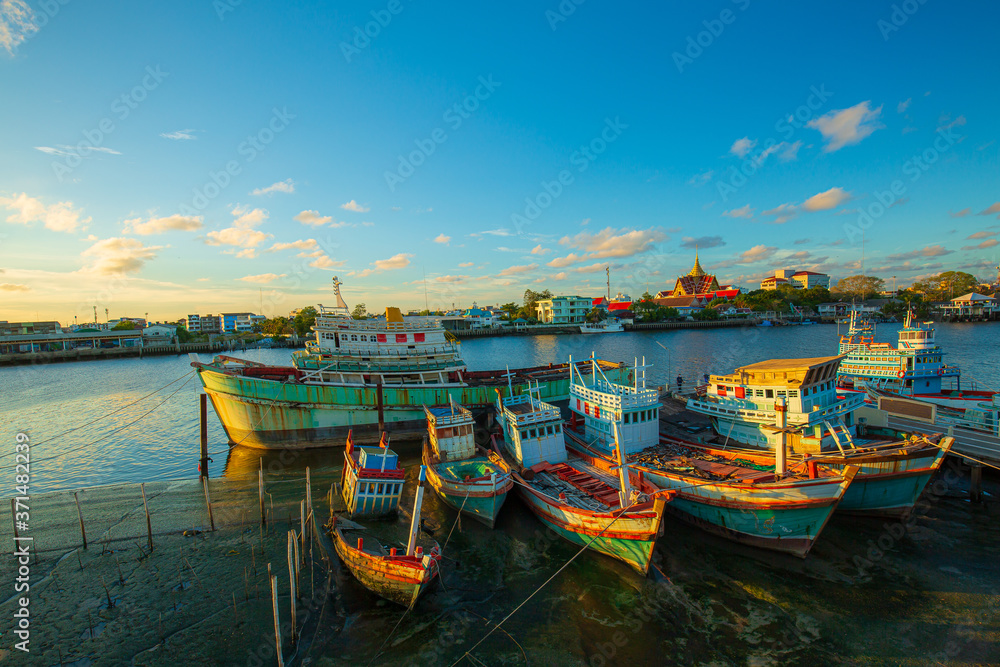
[0,324,1000,492]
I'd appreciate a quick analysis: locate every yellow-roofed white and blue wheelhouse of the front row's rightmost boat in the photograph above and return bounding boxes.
[687,356,864,453]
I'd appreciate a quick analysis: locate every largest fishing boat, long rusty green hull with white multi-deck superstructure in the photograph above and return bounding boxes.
[191,277,627,449]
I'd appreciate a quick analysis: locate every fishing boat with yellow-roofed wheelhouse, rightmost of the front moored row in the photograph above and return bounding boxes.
[687,355,954,517]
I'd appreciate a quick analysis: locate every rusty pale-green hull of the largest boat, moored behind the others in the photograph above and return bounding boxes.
[198,364,628,449]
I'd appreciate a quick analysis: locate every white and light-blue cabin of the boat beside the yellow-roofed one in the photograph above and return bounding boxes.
[569,358,660,454]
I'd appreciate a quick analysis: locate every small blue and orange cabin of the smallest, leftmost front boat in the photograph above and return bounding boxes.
[341,434,406,516]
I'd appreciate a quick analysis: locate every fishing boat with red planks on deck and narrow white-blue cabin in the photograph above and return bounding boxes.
[494,374,671,576]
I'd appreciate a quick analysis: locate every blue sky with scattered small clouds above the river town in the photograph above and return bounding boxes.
[0,0,1000,323]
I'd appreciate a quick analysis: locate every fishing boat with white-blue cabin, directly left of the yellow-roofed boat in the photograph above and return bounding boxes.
[566,359,857,558]
